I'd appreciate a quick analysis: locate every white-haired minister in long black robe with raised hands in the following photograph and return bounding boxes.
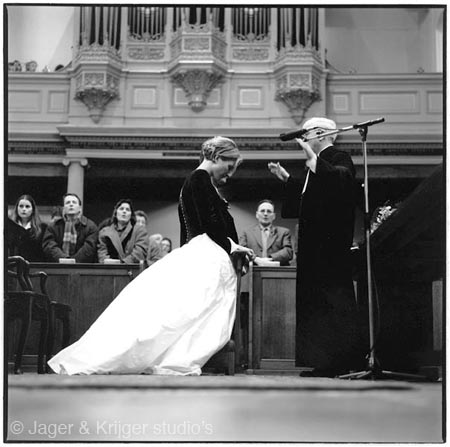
[268,117,363,377]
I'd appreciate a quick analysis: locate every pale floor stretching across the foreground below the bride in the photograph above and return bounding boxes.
[5,373,443,442]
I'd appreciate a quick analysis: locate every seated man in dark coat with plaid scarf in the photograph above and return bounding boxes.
[42,193,97,263]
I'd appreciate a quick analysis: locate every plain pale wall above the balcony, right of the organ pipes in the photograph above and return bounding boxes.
[323,7,442,74]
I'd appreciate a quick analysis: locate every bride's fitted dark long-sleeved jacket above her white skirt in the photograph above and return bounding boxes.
[178,169,238,254]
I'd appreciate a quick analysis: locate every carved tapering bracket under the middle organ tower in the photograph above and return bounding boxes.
[170,69,223,112]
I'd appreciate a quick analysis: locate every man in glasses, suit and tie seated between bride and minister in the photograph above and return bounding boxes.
[239,199,293,265]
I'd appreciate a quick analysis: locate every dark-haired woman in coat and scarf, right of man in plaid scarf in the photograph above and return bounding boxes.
[97,199,148,264]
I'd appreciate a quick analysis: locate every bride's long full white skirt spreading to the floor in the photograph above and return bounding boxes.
[48,234,236,375]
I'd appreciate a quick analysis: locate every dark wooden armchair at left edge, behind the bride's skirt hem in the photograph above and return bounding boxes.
[5,256,72,374]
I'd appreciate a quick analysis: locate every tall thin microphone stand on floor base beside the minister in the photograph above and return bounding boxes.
[338,118,427,380]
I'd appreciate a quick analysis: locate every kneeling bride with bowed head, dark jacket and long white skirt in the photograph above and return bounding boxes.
[48,137,253,375]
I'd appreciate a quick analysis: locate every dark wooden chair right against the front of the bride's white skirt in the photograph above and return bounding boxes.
[204,253,245,376]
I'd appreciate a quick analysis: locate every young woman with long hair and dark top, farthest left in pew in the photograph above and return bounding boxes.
[6,194,47,262]
